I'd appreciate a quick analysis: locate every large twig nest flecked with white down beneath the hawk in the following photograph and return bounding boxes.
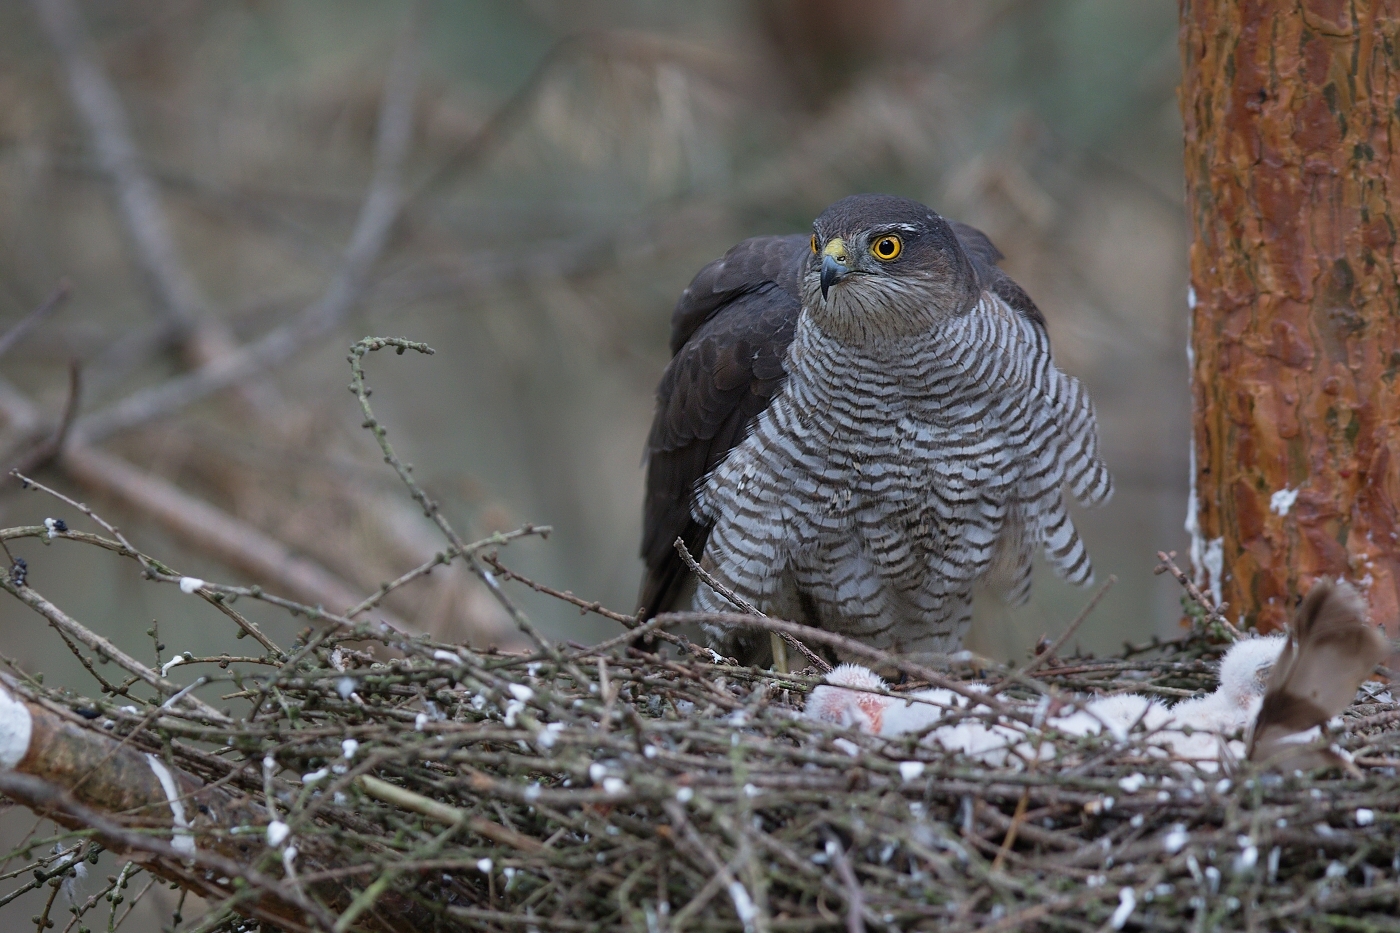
[0,340,1400,933]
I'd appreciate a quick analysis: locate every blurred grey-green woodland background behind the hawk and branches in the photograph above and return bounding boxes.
[0,0,1189,675]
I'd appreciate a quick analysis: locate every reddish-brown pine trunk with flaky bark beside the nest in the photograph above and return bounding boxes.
[1180,0,1400,630]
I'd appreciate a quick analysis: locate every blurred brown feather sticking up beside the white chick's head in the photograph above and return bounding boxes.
[1249,580,1390,768]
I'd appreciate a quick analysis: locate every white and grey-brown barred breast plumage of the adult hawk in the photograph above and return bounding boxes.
[694,293,1112,651]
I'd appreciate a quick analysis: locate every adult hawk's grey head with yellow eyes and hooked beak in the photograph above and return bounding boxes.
[802,195,979,345]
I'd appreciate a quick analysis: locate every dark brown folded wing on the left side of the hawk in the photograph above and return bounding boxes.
[640,235,809,618]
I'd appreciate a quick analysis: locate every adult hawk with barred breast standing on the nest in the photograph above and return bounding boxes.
[640,195,1112,664]
